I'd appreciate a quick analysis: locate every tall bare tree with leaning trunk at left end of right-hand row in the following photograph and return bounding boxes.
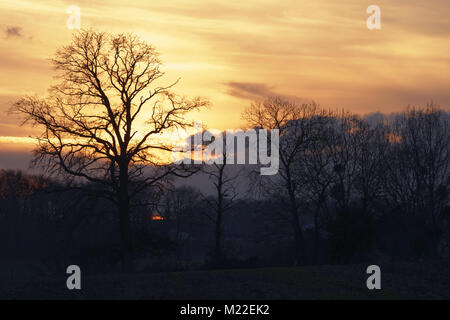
[242,97,322,259]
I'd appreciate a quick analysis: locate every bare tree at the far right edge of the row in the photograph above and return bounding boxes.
[386,104,450,257]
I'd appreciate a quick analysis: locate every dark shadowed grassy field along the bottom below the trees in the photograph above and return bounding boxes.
[0,262,450,300]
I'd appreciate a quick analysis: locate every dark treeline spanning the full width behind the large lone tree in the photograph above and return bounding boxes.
[0,101,450,272]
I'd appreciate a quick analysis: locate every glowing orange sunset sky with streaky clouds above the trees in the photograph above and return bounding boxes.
[0,0,450,168]
